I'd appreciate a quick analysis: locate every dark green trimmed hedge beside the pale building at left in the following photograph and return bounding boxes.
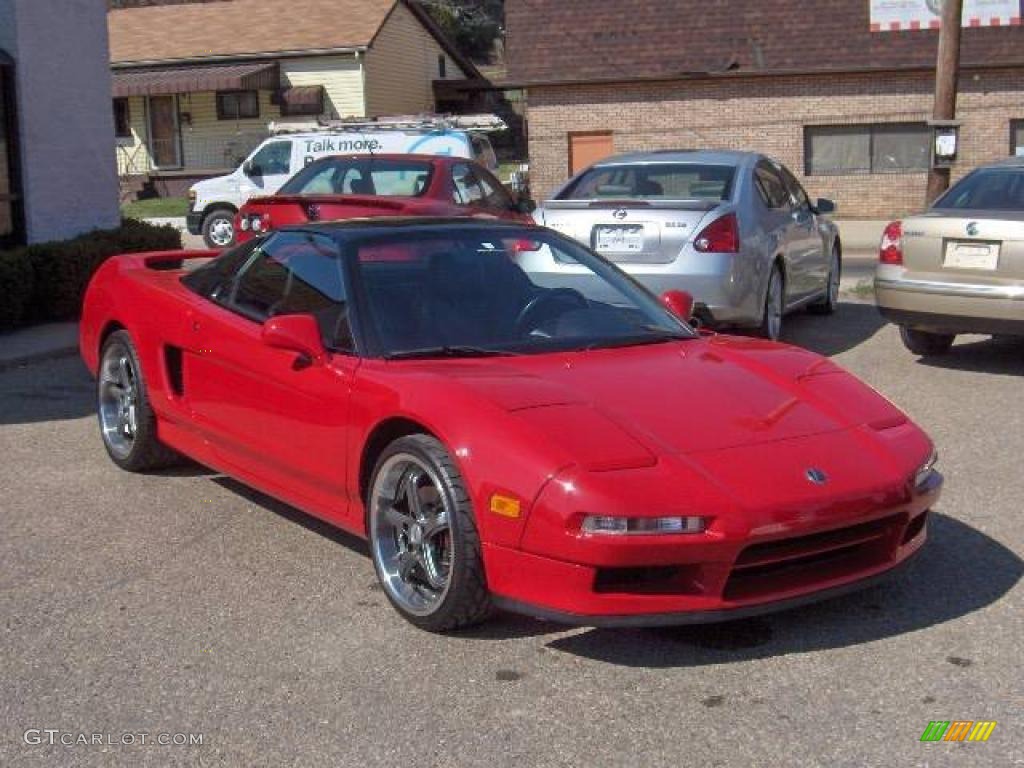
[0,219,181,331]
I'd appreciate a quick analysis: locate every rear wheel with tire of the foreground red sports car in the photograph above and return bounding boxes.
[96,331,178,472]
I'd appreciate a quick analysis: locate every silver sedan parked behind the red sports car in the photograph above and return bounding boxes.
[535,152,842,339]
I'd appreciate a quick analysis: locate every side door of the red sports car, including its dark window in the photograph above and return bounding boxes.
[186,232,358,520]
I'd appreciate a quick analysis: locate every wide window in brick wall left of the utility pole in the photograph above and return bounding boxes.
[804,123,931,176]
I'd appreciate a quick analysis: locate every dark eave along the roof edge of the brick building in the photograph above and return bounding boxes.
[505,60,1024,90]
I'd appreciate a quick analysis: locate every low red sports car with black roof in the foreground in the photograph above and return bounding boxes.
[81,219,942,631]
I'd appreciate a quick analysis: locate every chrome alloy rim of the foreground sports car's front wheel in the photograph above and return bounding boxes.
[370,454,454,616]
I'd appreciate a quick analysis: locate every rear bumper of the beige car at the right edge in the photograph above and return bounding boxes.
[874,270,1024,335]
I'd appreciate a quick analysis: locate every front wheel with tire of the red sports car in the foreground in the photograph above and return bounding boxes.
[367,434,492,632]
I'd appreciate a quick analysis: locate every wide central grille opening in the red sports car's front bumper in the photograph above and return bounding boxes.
[724,514,906,600]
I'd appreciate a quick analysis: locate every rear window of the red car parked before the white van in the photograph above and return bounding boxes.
[278,157,432,198]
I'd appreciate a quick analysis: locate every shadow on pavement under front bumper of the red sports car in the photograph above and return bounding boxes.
[548,513,1024,668]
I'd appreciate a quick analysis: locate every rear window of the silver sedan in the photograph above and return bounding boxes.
[559,163,735,203]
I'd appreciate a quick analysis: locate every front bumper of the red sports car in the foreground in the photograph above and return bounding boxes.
[483,472,942,627]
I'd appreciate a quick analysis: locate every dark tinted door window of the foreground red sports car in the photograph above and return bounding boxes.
[217,232,353,351]
